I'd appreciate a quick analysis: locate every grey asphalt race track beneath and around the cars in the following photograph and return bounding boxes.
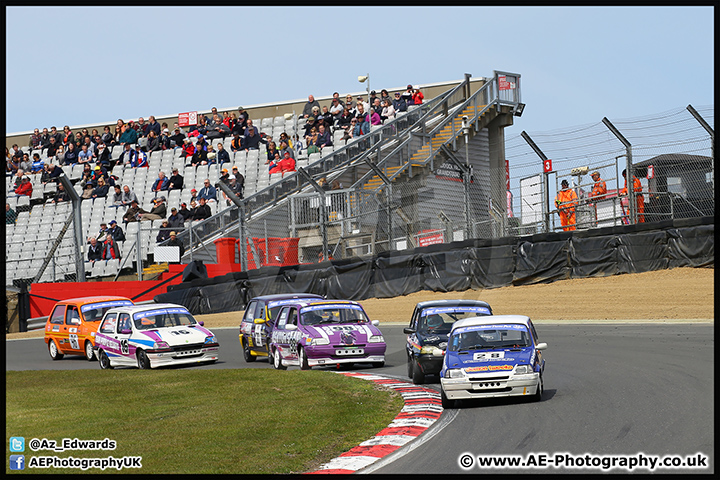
[6,321,715,474]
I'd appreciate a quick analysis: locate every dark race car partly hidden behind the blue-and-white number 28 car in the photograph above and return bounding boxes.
[403,300,492,384]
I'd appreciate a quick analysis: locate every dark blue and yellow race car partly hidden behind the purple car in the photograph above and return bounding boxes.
[238,293,323,363]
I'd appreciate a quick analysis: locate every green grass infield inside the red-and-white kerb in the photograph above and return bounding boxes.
[5,369,403,474]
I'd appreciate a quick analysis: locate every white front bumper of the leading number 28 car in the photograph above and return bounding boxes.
[440,373,540,400]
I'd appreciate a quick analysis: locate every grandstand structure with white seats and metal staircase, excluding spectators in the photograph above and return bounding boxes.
[6,72,520,286]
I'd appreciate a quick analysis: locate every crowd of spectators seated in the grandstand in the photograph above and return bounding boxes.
[6,85,423,260]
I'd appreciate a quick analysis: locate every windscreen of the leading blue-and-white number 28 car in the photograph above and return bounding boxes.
[448,324,532,352]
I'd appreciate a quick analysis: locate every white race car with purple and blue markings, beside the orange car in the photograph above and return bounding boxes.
[95,303,220,369]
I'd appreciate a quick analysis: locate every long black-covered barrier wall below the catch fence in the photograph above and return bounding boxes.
[155,216,715,321]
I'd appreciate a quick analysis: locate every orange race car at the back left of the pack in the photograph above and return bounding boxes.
[45,295,133,361]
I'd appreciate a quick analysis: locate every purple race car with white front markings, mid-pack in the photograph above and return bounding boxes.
[269,300,387,370]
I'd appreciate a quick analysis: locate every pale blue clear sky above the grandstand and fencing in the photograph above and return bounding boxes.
[5,6,715,138]
